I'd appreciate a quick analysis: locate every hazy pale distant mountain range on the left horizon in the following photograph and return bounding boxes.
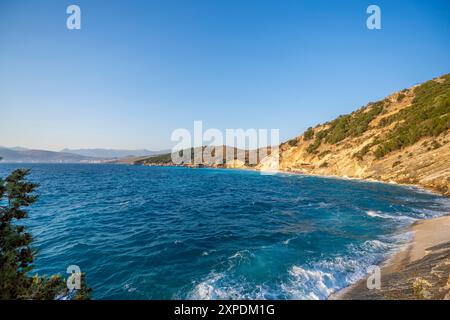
[0,147,167,163]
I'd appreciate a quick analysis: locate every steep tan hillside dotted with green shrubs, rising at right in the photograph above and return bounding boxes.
[268,74,450,195]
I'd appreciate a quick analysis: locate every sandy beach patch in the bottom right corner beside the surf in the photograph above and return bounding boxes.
[329,216,450,300]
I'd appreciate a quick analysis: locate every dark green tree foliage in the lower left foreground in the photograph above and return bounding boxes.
[0,169,91,300]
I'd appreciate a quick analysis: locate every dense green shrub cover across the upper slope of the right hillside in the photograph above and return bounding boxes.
[307,74,450,160]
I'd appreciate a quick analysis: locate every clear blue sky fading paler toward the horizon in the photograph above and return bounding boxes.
[0,0,450,150]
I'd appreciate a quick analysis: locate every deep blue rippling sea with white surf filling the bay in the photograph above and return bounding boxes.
[0,164,450,299]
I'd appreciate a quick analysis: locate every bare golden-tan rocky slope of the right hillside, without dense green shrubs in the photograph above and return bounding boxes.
[258,75,450,196]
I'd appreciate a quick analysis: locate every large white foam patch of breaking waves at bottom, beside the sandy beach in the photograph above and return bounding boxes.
[187,233,409,300]
